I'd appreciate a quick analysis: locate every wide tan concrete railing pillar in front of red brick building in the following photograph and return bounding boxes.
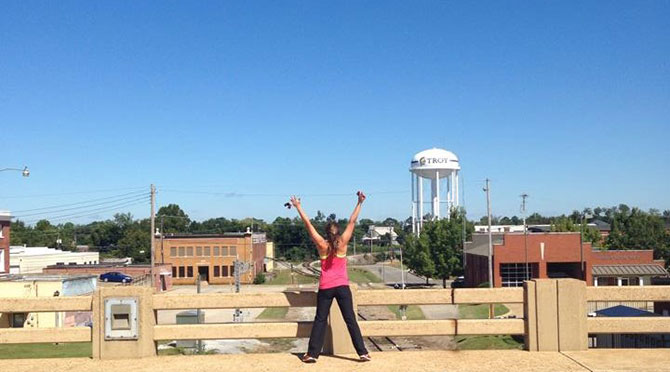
[524,279,588,351]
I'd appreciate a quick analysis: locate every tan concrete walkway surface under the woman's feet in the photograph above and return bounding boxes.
[2,349,670,372]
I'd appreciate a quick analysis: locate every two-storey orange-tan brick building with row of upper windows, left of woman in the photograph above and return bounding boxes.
[160,232,267,284]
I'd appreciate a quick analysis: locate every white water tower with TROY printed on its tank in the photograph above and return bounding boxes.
[409,148,461,234]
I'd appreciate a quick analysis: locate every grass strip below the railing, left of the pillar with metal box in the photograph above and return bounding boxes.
[0,342,92,359]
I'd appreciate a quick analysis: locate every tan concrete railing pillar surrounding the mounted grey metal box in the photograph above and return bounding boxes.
[92,286,156,359]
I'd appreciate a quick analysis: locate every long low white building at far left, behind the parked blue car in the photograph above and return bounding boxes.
[9,246,100,274]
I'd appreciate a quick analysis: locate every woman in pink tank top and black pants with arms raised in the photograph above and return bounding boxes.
[291,191,370,363]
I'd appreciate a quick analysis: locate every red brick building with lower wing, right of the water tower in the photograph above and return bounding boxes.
[465,232,668,287]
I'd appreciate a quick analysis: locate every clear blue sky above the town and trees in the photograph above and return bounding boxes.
[0,1,670,222]
